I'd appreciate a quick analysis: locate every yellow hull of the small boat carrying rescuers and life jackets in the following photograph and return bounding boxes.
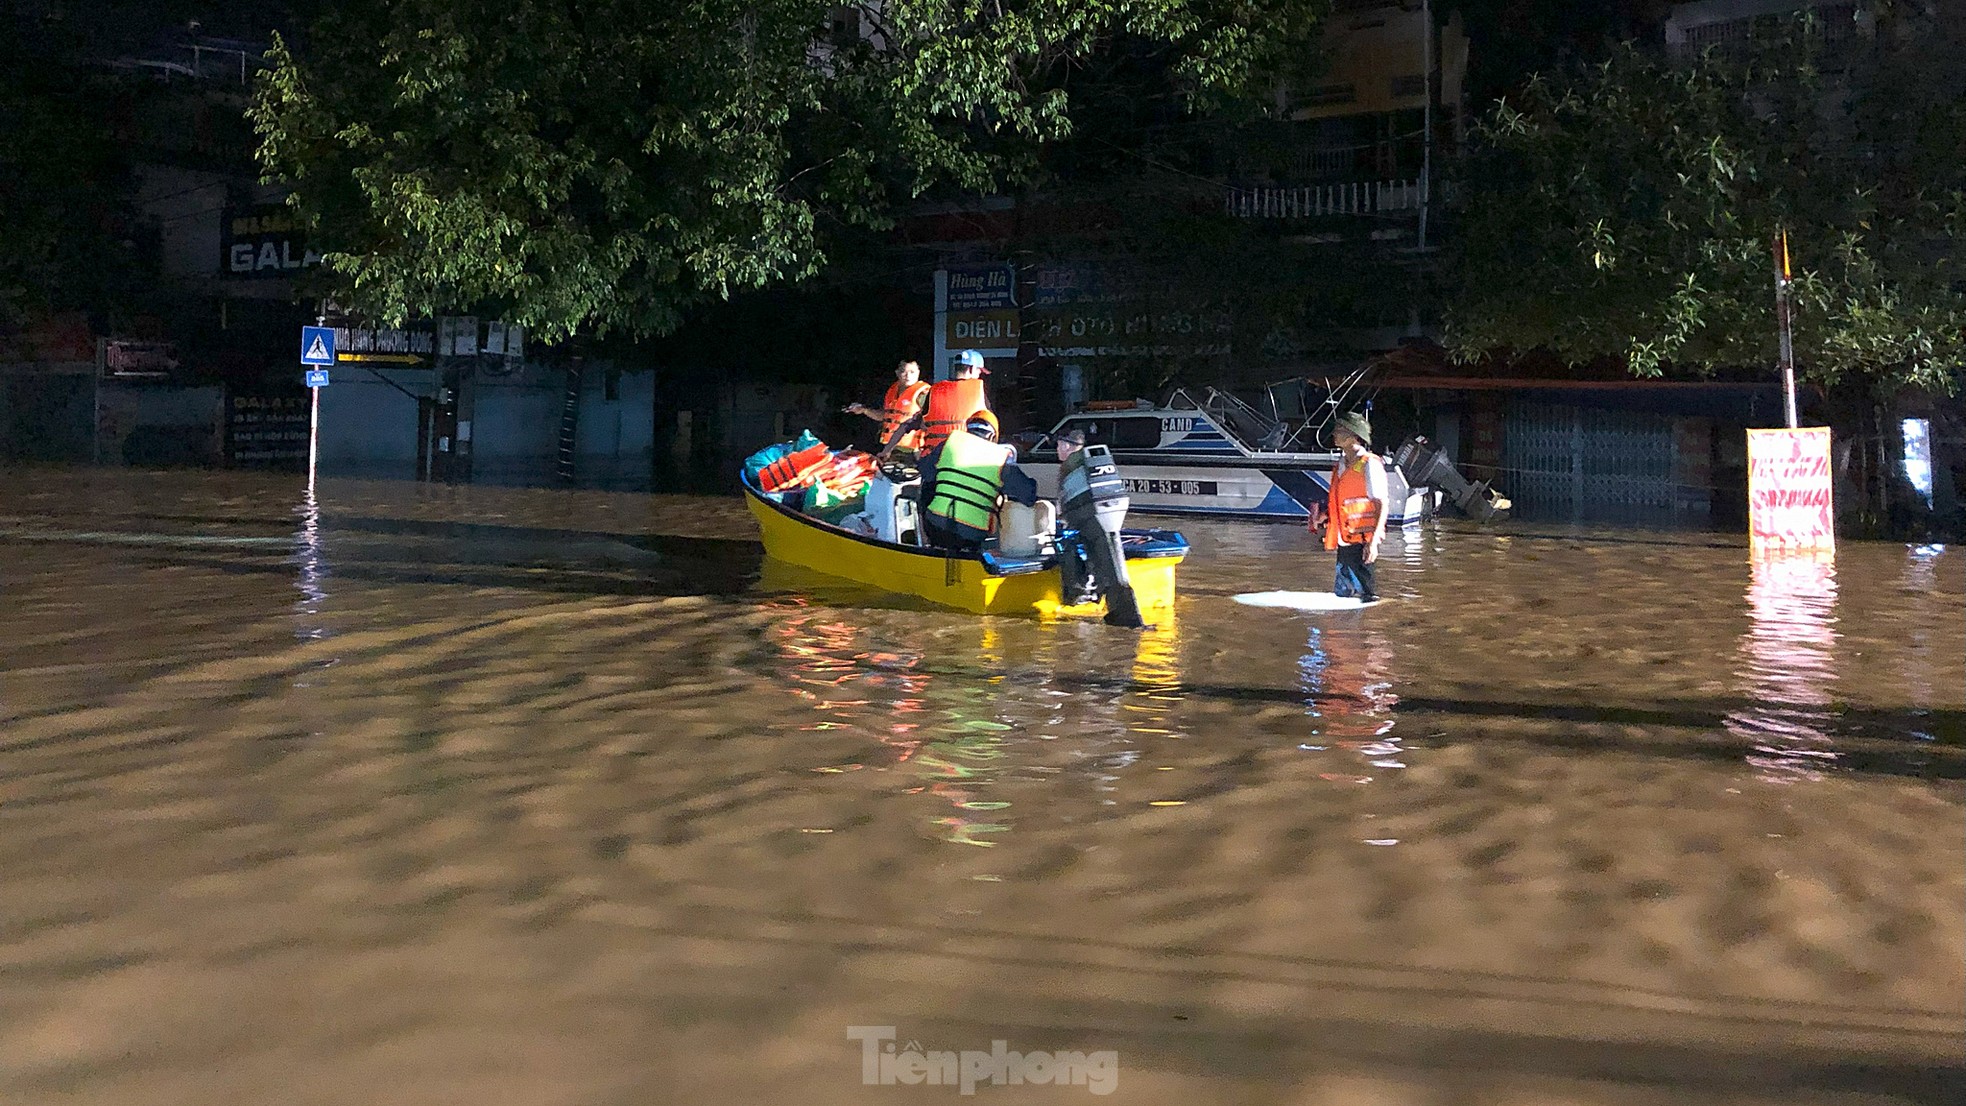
[743,473,1187,621]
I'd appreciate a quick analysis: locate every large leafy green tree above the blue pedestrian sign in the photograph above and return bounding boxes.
[252,0,1325,338]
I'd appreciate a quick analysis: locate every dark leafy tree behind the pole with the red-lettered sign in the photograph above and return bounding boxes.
[1449,6,1966,391]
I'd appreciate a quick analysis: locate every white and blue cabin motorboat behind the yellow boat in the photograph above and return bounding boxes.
[1022,387,1437,525]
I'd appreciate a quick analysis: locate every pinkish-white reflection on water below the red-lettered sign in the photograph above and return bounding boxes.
[1728,554,1836,784]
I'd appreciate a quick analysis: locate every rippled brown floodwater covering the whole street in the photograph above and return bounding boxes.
[0,470,1966,1106]
